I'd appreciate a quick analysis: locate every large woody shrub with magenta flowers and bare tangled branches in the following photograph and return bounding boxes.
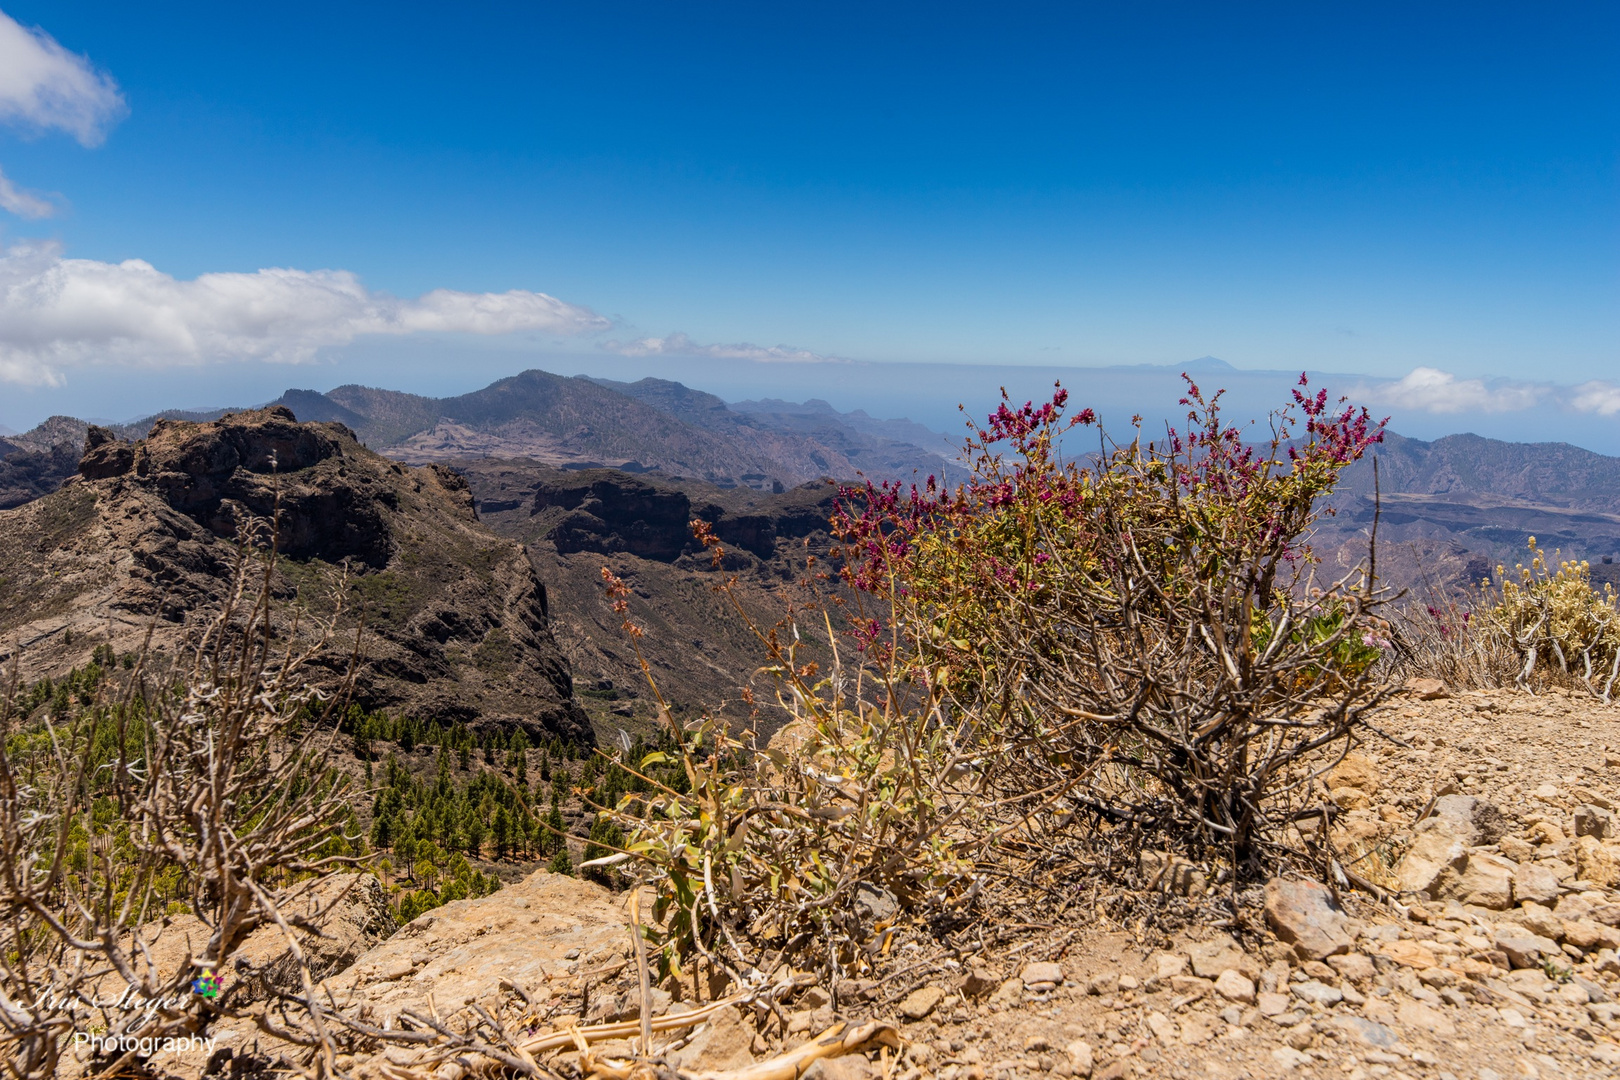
[834,376,1388,873]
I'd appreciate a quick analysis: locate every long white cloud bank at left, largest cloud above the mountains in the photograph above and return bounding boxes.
[0,244,611,384]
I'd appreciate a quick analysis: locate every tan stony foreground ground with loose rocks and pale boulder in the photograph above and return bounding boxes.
[57,693,1620,1080]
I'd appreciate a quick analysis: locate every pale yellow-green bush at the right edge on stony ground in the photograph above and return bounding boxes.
[1487,536,1620,699]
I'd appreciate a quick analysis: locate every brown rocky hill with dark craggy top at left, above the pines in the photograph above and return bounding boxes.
[0,406,588,738]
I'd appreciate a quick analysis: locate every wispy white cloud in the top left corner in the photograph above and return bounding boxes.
[0,11,126,146]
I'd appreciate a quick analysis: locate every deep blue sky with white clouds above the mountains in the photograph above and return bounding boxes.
[0,0,1620,452]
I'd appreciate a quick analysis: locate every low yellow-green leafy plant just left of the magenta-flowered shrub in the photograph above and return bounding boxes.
[596,563,990,1003]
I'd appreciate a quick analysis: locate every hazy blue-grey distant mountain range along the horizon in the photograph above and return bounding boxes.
[0,369,1620,595]
